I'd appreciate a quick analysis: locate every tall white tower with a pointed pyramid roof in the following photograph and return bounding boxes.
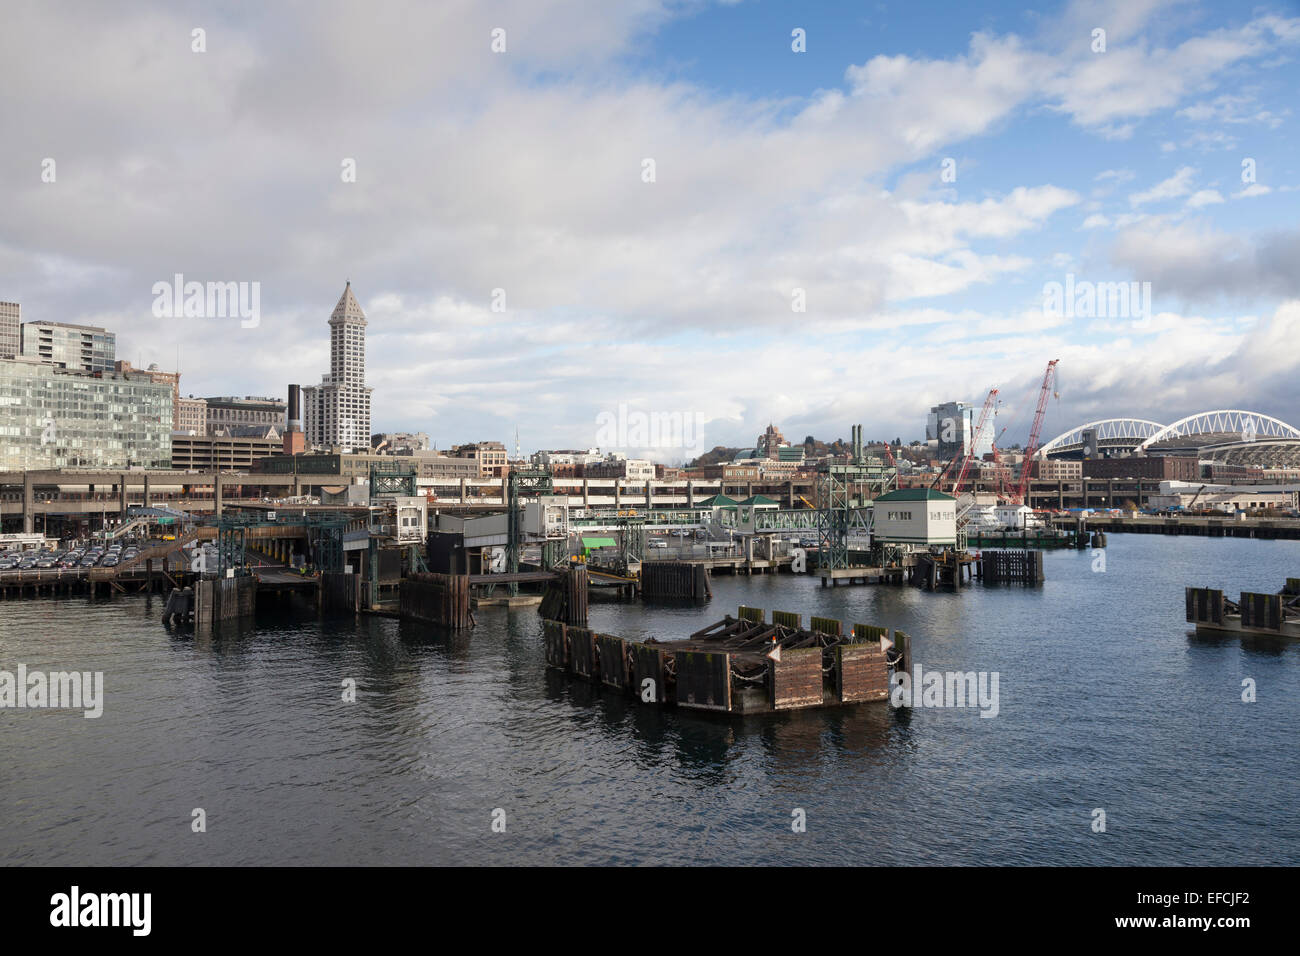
[303,282,371,451]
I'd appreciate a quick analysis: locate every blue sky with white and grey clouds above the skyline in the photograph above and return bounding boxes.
[0,0,1300,462]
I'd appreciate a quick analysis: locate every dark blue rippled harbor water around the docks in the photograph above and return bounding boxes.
[0,535,1300,865]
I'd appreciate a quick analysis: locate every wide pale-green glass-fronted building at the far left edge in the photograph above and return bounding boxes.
[0,359,172,471]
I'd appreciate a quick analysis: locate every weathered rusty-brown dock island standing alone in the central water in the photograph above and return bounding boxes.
[543,606,911,715]
